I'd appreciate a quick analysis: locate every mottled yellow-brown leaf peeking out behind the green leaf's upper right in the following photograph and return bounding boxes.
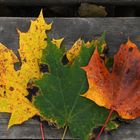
[66,33,106,63]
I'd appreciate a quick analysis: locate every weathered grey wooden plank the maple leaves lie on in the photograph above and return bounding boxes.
[0,18,140,140]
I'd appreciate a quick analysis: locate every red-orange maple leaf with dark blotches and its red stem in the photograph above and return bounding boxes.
[83,40,140,138]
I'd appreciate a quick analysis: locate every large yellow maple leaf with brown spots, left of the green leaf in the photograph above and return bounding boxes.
[0,11,53,127]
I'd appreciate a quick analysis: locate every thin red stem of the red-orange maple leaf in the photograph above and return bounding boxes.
[96,109,114,140]
